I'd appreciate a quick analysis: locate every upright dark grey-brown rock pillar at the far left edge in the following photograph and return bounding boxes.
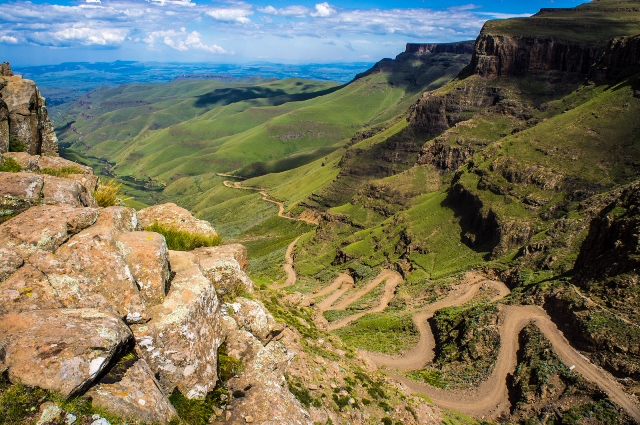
[0,62,58,156]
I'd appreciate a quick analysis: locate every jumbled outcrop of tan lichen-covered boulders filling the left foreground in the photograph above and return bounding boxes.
[0,153,311,425]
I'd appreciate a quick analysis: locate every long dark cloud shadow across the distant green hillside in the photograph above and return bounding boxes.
[194,85,344,108]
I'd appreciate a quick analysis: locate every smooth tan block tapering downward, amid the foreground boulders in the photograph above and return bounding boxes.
[116,232,169,306]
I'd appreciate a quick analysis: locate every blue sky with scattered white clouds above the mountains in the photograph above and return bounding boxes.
[0,0,585,66]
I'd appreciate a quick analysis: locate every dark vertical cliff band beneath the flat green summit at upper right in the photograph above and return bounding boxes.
[471,33,603,78]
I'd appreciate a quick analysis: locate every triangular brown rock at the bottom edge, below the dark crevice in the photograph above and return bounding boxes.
[87,359,177,424]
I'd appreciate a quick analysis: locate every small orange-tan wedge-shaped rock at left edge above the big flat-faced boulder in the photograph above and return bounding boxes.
[0,264,63,314]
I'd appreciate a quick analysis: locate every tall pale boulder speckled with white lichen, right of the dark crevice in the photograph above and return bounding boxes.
[132,251,223,399]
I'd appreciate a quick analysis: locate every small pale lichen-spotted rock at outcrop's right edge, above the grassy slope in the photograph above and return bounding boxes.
[229,298,284,344]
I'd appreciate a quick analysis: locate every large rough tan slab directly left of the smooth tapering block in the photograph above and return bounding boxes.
[48,207,150,323]
